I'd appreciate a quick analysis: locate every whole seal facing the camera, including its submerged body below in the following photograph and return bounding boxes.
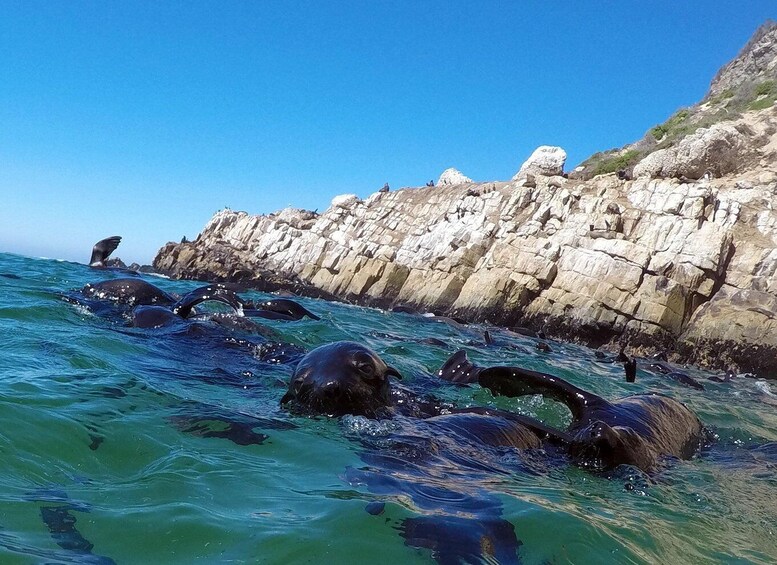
[281,341,555,563]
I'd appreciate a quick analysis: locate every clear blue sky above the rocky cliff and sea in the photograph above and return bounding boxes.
[0,0,777,263]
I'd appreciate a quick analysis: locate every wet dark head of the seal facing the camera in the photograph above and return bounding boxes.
[281,341,402,418]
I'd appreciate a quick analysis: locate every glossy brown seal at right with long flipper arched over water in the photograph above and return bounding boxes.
[438,351,703,471]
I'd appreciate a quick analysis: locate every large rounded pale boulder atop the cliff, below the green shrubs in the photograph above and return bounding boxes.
[634,123,747,179]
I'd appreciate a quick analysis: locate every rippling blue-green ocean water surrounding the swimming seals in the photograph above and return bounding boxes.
[0,255,777,564]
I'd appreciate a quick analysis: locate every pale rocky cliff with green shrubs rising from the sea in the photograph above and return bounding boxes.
[154,22,777,378]
